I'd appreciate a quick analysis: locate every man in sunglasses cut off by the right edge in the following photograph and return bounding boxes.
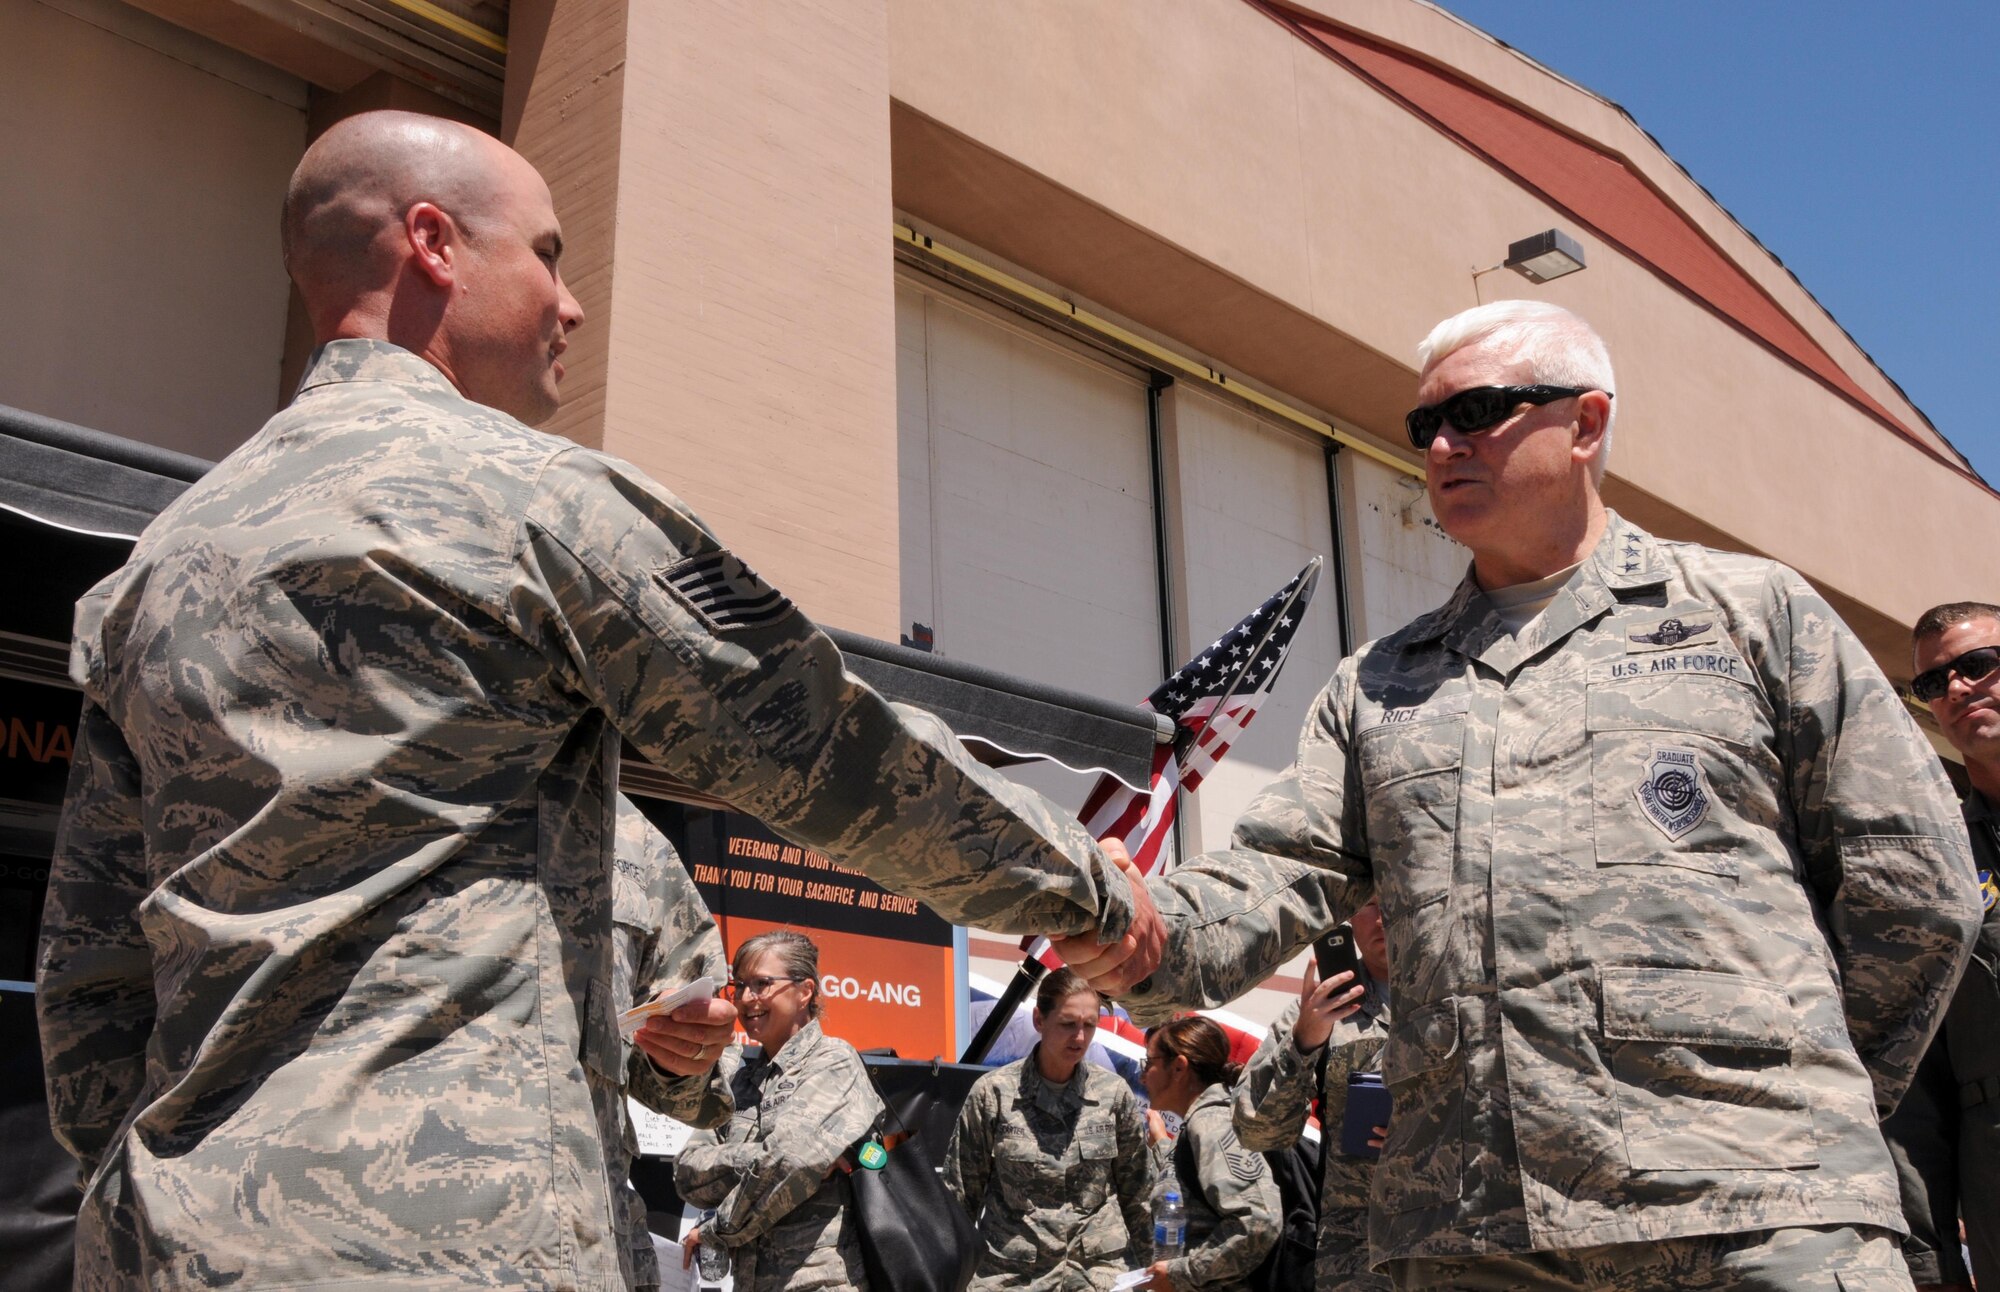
[1882,602,2000,1292]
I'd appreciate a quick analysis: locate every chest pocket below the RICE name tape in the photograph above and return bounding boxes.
[1356,714,1466,920]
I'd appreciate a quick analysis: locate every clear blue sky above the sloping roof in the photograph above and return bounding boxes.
[1440,0,2000,486]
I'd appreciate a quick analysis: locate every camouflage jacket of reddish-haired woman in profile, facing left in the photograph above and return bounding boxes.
[1152,1082,1280,1292]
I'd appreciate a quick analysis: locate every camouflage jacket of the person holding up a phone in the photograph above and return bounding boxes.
[1236,980,1390,1288]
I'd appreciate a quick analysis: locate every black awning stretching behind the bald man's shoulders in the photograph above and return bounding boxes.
[0,406,1174,800]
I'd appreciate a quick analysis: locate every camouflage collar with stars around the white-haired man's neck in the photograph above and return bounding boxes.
[1410,510,1668,676]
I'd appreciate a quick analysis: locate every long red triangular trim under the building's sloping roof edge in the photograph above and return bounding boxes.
[1246,0,1990,488]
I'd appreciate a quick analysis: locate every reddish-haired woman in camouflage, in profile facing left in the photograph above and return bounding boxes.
[1144,1014,1280,1292]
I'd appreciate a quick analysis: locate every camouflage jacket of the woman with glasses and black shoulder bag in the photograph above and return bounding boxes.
[674,1022,882,1292]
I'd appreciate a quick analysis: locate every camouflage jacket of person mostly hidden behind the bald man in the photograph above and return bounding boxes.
[608,794,734,1288]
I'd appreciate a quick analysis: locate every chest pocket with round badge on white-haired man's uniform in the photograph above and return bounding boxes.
[1584,680,1784,878]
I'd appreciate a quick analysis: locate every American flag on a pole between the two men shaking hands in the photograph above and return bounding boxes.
[1020,556,1320,968]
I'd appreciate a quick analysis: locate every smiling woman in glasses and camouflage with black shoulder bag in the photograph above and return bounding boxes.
[674,930,882,1292]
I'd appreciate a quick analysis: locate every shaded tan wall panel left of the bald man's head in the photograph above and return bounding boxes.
[0,0,306,458]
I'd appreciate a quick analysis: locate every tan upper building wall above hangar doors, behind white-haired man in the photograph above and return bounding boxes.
[890,0,2000,688]
